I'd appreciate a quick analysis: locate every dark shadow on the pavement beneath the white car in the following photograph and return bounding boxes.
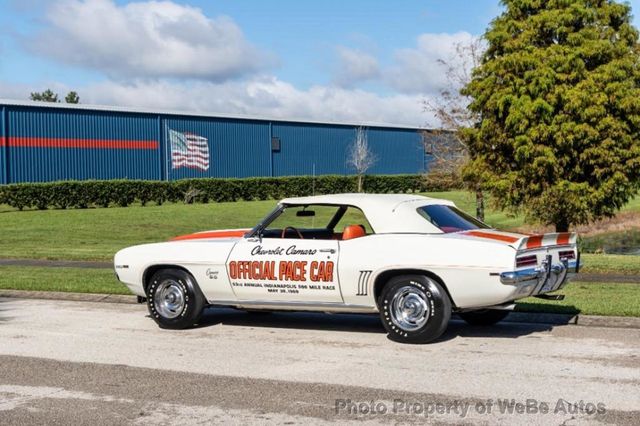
[190,308,554,342]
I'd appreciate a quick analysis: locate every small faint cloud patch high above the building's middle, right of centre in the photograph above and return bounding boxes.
[334,46,380,87]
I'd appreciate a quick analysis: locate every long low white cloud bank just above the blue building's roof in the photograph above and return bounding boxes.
[79,77,434,126]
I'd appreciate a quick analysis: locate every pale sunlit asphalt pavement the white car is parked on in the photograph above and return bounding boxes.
[0,299,640,424]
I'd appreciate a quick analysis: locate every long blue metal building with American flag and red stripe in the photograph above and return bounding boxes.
[0,100,436,183]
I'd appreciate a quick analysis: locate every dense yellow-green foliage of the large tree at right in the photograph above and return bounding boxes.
[462,0,640,232]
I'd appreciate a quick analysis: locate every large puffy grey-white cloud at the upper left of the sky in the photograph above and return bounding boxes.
[29,0,272,81]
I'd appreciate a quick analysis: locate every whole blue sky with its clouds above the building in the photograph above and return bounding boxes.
[0,0,640,125]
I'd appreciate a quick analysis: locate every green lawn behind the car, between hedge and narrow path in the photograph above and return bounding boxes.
[0,191,640,274]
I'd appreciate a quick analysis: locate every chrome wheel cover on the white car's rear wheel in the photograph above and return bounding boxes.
[390,286,431,331]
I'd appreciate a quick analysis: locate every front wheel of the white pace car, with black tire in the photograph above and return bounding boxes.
[147,268,206,330]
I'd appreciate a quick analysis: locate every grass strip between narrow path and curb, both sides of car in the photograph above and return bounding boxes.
[0,266,640,317]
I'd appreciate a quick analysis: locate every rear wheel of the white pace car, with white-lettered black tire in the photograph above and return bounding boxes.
[378,275,451,343]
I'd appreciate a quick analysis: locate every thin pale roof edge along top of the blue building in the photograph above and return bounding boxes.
[0,98,447,131]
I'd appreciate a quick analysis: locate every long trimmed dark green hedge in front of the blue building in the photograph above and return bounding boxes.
[0,175,458,210]
